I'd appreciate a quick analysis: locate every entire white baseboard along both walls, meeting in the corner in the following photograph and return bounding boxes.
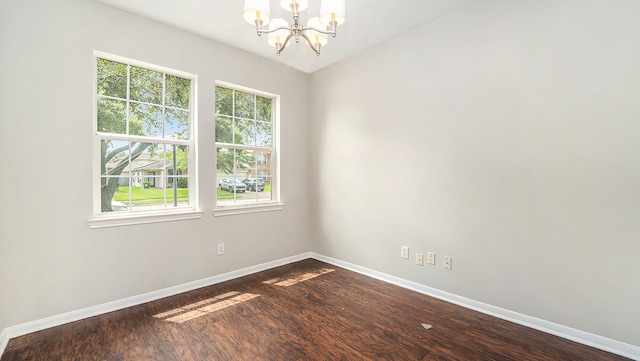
[0,252,640,361]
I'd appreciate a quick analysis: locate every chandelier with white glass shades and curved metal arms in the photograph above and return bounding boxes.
[244,0,345,56]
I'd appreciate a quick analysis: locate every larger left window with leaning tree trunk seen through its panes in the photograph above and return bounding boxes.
[90,52,197,225]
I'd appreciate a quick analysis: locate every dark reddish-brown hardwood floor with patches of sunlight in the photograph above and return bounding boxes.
[0,259,626,361]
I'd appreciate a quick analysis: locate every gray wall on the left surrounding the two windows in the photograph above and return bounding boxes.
[0,0,310,329]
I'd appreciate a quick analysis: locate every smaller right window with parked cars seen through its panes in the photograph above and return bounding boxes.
[215,83,279,214]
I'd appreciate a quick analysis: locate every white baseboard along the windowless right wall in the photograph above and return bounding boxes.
[311,253,640,360]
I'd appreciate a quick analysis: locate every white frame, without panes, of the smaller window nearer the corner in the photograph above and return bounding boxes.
[213,80,284,216]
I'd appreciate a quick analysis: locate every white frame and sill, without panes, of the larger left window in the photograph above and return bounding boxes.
[88,51,203,228]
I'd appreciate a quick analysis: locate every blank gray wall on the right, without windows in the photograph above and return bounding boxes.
[311,0,640,346]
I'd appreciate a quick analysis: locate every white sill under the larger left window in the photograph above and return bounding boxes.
[87,209,203,229]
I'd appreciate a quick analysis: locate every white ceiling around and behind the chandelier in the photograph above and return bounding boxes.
[97,0,476,73]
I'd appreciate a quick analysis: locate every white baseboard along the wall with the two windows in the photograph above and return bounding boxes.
[0,252,312,355]
